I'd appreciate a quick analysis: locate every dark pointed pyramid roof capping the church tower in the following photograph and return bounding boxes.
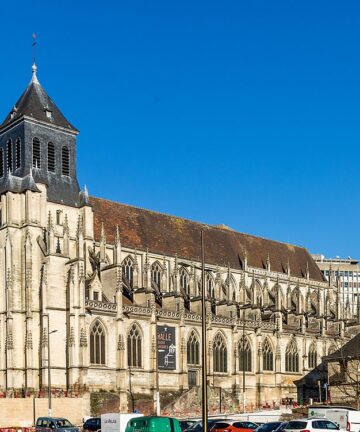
[0,65,78,133]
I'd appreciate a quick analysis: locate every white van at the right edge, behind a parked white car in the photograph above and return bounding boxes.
[308,405,360,432]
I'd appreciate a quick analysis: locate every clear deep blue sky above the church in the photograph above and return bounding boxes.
[0,0,360,257]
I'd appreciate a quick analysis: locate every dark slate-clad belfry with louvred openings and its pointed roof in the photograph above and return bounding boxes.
[0,64,84,207]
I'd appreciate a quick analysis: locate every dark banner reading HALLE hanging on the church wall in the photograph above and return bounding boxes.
[156,326,176,370]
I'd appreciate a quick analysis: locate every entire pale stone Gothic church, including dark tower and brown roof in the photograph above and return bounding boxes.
[0,65,345,410]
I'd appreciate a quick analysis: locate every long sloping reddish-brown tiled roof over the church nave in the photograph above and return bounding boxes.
[90,197,324,282]
